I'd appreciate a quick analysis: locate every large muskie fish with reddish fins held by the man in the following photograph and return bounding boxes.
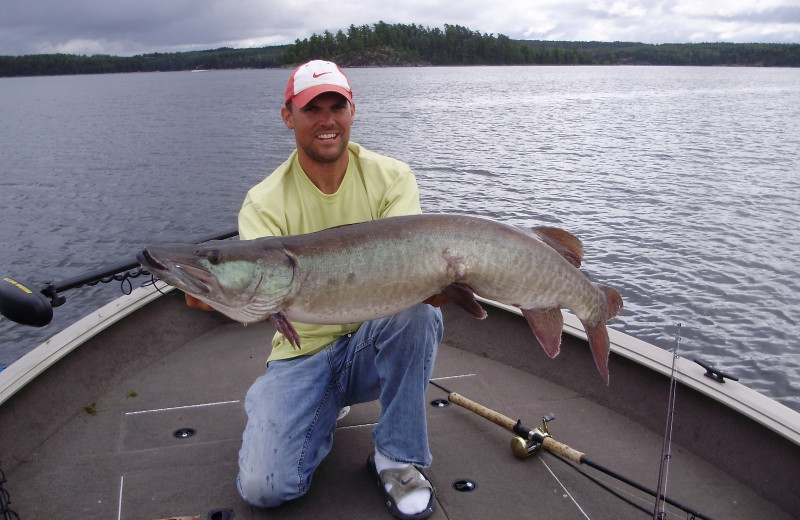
[138,214,622,384]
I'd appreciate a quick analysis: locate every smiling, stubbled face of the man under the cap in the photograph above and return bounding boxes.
[281,92,355,163]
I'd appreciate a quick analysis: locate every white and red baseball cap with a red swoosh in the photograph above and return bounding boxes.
[285,60,353,108]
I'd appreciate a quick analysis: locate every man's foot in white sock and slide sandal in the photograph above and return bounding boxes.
[367,450,434,520]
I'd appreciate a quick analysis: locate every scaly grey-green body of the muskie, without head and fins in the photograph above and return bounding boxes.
[278,215,592,323]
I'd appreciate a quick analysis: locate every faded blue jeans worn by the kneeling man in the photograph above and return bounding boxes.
[237,303,444,507]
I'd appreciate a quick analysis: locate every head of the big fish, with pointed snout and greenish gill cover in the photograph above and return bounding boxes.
[137,239,295,323]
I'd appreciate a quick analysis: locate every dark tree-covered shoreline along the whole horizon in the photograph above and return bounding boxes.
[0,22,800,77]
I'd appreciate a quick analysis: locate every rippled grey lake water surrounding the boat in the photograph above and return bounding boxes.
[0,67,800,410]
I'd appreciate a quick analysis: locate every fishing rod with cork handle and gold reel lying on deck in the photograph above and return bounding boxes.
[429,381,712,520]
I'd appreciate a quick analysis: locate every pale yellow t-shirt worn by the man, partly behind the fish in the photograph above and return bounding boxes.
[239,142,422,361]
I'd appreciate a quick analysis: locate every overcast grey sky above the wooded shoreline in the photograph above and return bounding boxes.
[0,0,800,56]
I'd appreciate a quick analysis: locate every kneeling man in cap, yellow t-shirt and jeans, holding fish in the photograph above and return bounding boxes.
[225,60,443,518]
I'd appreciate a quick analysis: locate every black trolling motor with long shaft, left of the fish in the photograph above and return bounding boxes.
[0,225,239,327]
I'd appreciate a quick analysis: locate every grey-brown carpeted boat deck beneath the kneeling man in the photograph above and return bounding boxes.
[0,292,793,520]
